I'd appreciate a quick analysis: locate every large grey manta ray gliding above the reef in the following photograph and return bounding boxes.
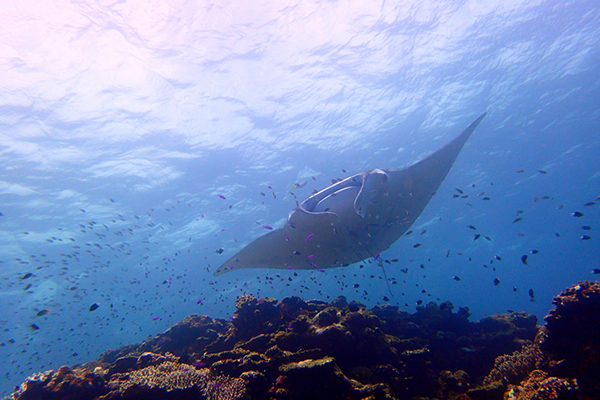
[215,113,487,276]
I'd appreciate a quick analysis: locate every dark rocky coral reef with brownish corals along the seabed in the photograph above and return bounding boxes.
[12,283,600,400]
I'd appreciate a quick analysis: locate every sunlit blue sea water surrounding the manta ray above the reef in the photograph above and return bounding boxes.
[0,0,600,394]
